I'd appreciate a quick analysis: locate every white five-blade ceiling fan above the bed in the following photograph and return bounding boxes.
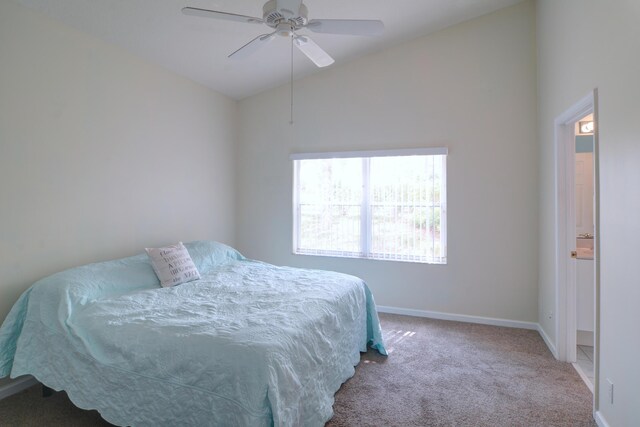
[182,0,384,67]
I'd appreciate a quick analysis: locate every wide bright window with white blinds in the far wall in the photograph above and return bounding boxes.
[291,148,447,264]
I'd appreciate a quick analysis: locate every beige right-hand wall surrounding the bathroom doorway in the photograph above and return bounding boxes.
[537,0,640,426]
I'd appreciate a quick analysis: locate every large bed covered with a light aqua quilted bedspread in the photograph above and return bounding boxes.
[0,241,386,426]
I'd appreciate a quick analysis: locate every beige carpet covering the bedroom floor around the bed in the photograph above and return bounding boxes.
[0,314,596,427]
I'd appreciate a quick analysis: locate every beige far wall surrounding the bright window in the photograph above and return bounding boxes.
[237,1,538,322]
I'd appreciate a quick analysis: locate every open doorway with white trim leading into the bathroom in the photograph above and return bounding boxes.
[555,90,600,402]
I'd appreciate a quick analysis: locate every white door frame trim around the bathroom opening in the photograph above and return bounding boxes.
[554,89,601,410]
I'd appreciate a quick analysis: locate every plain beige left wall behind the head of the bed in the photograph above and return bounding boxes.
[0,1,237,319]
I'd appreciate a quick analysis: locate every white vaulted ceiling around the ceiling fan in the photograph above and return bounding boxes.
[12,0,521,99]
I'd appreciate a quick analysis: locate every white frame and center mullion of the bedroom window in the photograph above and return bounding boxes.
[289,147,449,265]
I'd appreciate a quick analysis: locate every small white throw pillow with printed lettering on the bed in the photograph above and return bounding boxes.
[145,242,200,288]
